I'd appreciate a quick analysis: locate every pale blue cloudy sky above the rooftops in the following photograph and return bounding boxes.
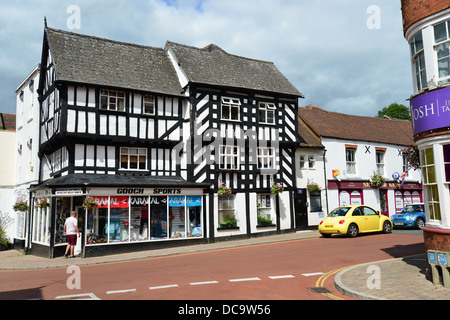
[0,0,413,116]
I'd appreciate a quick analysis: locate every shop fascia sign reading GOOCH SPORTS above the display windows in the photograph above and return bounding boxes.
[87,187,202,196]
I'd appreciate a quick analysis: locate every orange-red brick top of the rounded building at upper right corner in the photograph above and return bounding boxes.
[401,0,450,33]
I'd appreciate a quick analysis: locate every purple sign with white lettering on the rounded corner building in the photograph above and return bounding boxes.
[411,87,450,135]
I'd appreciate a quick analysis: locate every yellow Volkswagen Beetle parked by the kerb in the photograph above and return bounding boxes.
[319,205,392,238]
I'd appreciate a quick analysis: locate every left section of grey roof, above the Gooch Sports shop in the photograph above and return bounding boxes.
[46,28,182,95]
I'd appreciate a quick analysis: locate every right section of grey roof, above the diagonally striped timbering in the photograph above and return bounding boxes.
[166,42,303,98]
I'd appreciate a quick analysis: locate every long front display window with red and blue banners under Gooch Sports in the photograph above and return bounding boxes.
[86,196,203,245]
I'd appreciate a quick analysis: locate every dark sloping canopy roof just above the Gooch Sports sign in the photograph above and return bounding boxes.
[30,174,211,192]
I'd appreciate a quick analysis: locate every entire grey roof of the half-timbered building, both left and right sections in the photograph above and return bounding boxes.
[46,28,303,97]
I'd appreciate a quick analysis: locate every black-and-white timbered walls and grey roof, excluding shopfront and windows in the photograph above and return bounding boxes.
[30,27,302,258]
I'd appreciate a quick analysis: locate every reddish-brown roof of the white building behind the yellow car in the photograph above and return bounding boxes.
[298,105,414,146]
